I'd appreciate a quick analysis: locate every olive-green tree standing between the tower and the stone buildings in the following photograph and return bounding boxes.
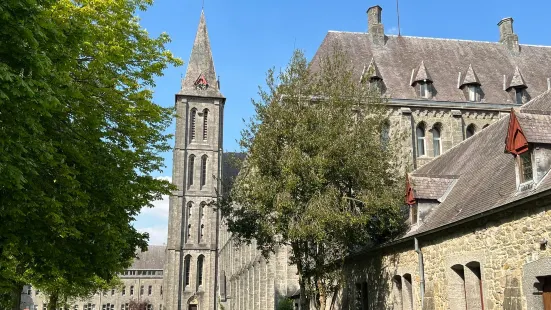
[218,46,404,309]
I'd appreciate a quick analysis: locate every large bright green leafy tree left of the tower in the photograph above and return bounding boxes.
[0,0,182,309]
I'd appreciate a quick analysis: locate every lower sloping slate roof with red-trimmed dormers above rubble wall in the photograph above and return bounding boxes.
[406,91,551,236]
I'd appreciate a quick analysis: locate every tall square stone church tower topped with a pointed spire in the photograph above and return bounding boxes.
[164,12,225,310]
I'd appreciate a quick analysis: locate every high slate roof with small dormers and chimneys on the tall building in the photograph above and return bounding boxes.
[312,31,551,104]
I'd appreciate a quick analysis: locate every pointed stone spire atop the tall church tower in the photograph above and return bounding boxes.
[179,11,223,98]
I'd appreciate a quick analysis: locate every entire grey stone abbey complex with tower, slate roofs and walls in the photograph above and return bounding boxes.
[22,6,551,310]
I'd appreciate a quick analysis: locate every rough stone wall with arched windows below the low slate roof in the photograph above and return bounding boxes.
[336,196,551,310]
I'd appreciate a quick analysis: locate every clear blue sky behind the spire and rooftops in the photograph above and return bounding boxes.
[135,0,551,244]
